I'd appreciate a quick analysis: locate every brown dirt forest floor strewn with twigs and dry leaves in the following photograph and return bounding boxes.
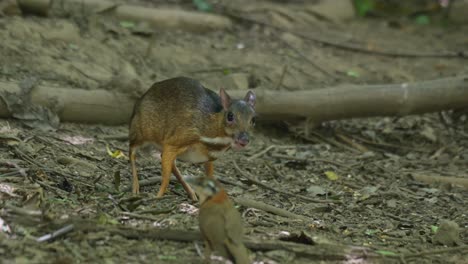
[0,1,468,263]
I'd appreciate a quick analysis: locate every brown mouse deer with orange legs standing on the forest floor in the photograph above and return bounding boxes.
[129,77,256,200]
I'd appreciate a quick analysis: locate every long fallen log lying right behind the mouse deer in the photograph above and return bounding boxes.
[0,76,468,125]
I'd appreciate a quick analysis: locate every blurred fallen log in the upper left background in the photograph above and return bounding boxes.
[18,0,232,32]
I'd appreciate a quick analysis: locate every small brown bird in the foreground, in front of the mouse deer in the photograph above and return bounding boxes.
[187,177,251,264]
